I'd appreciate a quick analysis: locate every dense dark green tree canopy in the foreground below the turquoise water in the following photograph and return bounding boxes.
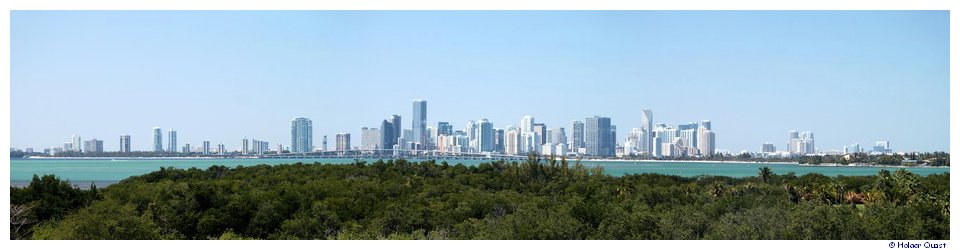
[10,156,950,240]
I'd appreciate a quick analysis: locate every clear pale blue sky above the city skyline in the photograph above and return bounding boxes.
[10,11,949,152]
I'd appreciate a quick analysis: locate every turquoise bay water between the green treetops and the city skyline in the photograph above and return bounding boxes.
[10,158,950,186]
